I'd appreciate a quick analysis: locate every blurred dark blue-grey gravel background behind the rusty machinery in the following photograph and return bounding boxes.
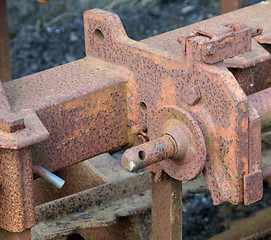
[4,0,271,239]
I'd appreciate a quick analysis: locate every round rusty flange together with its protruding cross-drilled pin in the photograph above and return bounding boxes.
[122,106,206,181]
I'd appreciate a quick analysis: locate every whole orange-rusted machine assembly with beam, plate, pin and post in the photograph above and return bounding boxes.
[0,2,271,239]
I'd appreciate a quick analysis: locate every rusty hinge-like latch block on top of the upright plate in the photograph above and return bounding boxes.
[177,23,263,64]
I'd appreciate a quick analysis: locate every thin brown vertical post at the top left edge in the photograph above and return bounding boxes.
[0,0,11,82]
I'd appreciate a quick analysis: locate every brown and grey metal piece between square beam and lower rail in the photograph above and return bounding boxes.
[34,153,133,206]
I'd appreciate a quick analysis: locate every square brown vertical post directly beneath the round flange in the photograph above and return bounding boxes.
[151,173,182,240]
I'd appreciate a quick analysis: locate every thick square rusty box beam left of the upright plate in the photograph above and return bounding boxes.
[4,57,129,172]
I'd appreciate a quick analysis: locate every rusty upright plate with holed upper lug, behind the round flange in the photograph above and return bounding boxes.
[84,10,264,204]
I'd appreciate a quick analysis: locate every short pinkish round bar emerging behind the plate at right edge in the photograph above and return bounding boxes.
[248,88,271,130]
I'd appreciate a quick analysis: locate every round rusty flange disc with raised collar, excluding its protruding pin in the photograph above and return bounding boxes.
[148,106,207,181]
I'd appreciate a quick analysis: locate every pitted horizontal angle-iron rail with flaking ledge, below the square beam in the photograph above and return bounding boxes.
[32,172,150,240]
